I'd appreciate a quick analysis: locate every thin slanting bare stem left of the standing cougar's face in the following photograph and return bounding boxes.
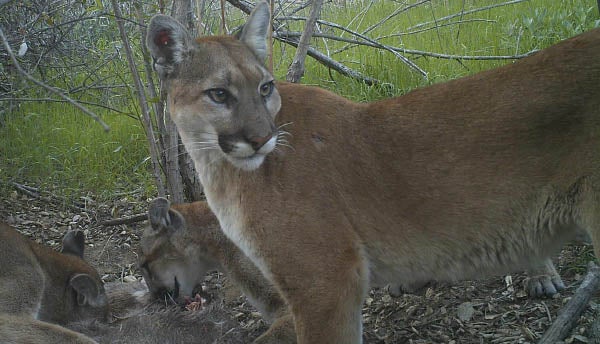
[111,0,165,197]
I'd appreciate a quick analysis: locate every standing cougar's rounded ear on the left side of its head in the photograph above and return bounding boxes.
[146,14,193,78]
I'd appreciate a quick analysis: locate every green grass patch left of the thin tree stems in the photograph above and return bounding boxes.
[0,103,154,199]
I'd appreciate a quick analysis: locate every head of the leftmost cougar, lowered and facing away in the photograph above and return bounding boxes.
[61,231,109,321]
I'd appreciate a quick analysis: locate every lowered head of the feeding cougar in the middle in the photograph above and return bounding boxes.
[139,198,223,302]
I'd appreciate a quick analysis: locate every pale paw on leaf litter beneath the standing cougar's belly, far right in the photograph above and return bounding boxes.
[525,258,565,297]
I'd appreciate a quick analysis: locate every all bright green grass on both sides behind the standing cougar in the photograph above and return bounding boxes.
[0,0,600,202]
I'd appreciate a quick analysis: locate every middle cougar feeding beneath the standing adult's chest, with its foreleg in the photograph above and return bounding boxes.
[139,198,294,343]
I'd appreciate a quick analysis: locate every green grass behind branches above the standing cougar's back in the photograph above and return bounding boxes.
[274,0,600,101]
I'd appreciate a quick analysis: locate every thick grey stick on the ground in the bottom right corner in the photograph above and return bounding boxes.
[538,262,600,344]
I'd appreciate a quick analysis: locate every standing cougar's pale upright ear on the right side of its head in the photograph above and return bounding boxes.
[239,1,271,61]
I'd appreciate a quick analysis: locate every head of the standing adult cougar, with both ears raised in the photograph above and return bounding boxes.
[146,2,281,170]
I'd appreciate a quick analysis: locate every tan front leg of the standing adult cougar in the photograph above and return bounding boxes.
[274,240,369,344]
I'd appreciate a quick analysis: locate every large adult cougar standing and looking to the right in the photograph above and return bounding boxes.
[147,2,600,343]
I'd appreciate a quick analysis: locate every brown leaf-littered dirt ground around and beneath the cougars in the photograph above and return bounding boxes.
[0,190,600,343]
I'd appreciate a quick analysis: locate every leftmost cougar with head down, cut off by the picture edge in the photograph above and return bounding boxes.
[0,223,108,324]
